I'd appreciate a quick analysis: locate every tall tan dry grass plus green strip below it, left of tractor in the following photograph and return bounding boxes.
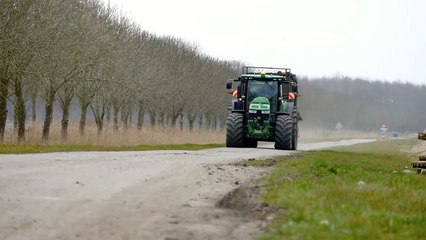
[0,121,225,154]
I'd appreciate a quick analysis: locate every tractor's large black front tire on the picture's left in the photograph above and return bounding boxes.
[226,113,244,147]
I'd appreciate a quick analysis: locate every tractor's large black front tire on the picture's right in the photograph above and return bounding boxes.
[275,115,293,150]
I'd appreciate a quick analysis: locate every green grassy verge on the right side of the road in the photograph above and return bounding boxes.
[262,141,426,239]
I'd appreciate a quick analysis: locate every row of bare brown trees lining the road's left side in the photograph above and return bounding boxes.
[0,0,240,142]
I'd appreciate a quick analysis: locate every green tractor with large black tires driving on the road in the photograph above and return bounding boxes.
[226,67,302,150]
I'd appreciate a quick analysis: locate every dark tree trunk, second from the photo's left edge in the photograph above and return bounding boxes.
[15,78,26,143]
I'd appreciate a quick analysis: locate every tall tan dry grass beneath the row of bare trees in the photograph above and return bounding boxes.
[3,121,225,147]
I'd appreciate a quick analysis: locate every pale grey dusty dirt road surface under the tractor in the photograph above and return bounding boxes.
[0,139,371,240]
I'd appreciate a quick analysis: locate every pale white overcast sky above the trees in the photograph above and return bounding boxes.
[103,0,426,84]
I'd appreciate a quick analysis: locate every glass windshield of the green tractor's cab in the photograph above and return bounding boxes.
[247,80,278,112]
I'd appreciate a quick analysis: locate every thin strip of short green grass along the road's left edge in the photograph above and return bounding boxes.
[0,144,225,154]
